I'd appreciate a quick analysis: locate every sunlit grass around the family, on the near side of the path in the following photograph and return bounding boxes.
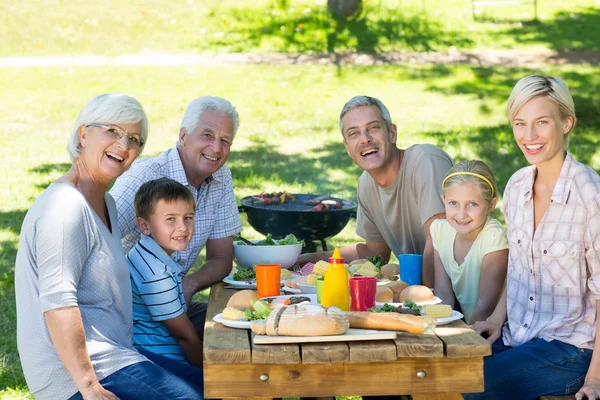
[0,65,600,398]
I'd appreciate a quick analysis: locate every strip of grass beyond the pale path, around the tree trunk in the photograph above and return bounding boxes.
[0,0,600,56]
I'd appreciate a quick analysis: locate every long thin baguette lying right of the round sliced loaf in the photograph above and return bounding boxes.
[346,311,435,334]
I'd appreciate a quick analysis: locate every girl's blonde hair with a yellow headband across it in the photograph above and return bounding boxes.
[442,160,498,204]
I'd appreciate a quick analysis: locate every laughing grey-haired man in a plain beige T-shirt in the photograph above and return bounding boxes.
[298,96,452,287]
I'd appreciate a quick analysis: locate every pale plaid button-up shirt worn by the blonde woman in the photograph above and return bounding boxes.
[503,153,600,349]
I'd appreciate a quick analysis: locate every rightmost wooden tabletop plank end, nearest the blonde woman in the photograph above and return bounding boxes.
[435,320,492,358]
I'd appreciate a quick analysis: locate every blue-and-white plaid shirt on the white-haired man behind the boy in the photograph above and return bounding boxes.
[110,148,242,273]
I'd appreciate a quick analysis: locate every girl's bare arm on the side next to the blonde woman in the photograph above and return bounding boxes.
[467,249,508,325]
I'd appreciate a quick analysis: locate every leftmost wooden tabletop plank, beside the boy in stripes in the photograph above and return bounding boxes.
[204,283,252,365]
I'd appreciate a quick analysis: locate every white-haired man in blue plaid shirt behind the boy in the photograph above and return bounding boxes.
[110,96,242,337]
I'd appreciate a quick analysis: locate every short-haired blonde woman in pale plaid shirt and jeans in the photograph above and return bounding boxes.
[465,76,600,400]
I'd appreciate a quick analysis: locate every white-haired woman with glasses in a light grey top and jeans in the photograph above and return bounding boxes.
[15,94,202,399]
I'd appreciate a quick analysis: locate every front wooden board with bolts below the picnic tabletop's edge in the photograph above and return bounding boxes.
[204,357,483,398]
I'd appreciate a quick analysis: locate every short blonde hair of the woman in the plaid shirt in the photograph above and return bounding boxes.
[506,75,577,148]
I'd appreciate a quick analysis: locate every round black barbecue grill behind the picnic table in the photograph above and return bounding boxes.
[239,194,356,252]
